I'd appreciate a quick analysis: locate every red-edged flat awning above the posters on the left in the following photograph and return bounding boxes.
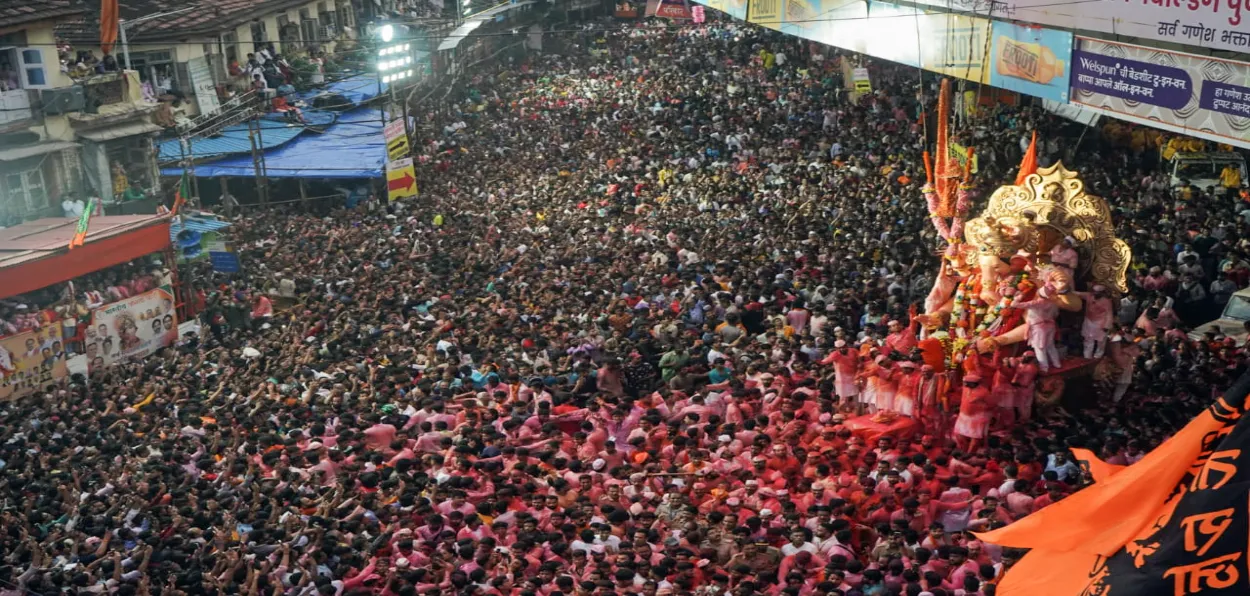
[0,215,170,299]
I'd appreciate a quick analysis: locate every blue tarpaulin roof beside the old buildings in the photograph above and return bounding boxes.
[161,107,386,179]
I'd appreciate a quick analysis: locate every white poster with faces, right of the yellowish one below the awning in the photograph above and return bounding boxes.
[85,287,178,371]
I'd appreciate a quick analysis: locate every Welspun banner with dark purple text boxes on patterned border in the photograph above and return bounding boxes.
[1069,37,1250,149]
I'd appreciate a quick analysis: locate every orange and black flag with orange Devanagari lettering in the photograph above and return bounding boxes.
[978,372,1250,596]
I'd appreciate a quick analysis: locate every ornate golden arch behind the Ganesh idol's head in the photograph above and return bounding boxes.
[965,162,1133,292]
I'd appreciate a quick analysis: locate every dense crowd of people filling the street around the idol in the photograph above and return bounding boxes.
[0,16,1250,596]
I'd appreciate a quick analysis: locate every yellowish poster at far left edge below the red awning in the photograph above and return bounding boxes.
[0,324,70,401]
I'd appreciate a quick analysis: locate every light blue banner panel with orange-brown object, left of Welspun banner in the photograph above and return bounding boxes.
[990,21,1073,101]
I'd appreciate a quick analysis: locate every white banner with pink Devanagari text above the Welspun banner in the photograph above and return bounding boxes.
[916,0,1250,52]
